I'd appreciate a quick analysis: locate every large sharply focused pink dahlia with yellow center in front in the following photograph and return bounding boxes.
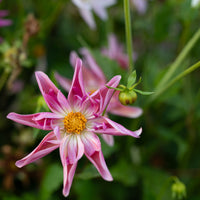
[7,59,142,196]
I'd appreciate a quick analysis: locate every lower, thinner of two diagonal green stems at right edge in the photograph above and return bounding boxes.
[151,61,200,101]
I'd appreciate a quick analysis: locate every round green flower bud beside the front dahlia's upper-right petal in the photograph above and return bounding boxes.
[119,90,137,105]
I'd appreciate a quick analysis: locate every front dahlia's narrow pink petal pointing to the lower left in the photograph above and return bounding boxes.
[16,131,60,168]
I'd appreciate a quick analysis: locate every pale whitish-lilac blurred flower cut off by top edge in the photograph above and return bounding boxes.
[72,0,116,29]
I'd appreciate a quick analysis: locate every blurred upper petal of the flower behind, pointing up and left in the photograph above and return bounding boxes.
[80,48,106,84]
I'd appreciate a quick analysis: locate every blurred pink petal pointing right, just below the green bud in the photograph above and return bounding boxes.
[107,99,142,118]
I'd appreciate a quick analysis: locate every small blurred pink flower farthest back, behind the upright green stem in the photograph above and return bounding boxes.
[102,34,136,69]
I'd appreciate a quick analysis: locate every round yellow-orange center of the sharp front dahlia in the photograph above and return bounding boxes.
[64,112,87,134]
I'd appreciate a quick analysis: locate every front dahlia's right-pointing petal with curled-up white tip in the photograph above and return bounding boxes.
[95,117,142,138]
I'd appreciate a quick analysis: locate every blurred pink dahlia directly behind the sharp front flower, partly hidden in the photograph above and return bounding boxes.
[56,48,142,146]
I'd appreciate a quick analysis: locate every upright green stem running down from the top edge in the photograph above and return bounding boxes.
[124,0,133,73]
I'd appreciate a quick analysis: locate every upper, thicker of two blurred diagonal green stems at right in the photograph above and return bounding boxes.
[157,28,200,89]
